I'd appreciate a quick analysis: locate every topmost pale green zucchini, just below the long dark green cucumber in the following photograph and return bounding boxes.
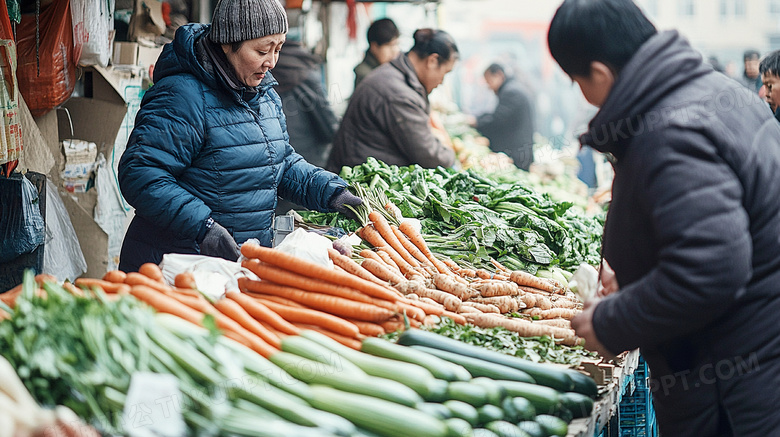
[360,337,471,381]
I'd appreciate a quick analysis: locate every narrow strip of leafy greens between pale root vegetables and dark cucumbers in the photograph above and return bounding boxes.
[385,317,598,367]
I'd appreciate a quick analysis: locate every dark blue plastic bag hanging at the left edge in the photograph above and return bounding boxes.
[0,173,46,262]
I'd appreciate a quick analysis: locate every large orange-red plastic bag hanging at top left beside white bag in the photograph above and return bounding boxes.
[16,0,76,117]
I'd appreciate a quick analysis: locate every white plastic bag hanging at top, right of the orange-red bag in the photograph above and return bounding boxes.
[70,0,114,67]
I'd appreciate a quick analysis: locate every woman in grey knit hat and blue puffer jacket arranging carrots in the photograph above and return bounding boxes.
[119,0,360,271]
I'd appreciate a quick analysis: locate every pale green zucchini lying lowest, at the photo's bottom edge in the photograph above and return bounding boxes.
[308,385,449,437]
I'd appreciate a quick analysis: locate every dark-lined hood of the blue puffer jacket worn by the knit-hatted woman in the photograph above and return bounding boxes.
[154,23,276,96]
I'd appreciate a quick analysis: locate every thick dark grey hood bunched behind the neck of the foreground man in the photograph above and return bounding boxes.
[580,31,713,158]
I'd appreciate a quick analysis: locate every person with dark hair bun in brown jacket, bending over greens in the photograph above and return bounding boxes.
[326,29,458,172]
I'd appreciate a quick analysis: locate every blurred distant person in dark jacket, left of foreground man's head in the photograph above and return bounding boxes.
[473,64,534,170]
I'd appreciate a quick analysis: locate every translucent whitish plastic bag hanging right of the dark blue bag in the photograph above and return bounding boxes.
[43,179,87,281]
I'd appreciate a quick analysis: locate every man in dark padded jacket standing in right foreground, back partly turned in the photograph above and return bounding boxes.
[548,0,780,437]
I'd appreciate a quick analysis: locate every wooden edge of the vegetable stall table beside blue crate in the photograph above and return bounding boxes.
[567,349,639,437]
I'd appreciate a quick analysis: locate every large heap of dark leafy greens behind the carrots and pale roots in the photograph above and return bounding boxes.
[301,158,603,273]
